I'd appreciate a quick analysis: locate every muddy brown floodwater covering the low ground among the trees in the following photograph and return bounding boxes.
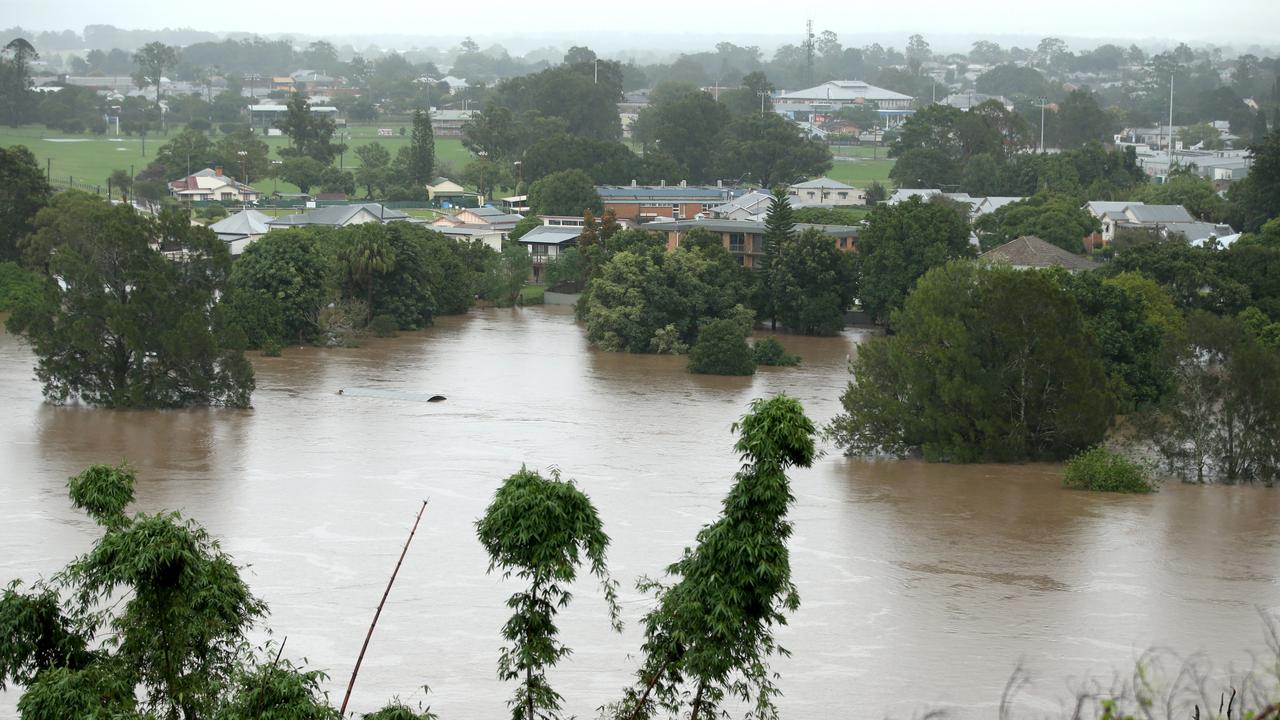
[0,307,1280,719]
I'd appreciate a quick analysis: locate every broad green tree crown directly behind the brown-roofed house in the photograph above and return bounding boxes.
[974,192,1102,254]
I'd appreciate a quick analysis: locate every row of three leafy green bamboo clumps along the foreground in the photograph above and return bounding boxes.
[0,396,815,720]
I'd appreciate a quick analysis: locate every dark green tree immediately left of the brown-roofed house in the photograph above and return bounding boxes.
[858,197,973,323]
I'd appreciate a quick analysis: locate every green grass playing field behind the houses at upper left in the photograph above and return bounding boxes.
[0,123,472,193]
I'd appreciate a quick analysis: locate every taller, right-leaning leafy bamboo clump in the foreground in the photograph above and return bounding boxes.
[614,395,815,719]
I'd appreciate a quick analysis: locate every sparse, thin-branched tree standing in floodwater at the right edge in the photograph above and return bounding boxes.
[1147,311,1280,486]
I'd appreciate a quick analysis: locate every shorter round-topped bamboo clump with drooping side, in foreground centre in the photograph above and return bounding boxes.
[476,468,622,720]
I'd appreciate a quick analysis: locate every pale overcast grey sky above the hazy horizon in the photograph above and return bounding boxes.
[0,0,1280,49]
